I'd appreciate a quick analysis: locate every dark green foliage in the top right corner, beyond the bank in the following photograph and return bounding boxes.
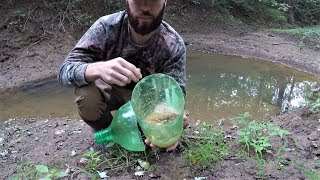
[215,0,320,26]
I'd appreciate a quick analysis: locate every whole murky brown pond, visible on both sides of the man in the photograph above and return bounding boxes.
[0,52,320,122]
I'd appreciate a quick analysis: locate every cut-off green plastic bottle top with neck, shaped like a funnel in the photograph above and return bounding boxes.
[94,101,145,151]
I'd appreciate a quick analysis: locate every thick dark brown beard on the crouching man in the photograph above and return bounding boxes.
[127,3,165,36]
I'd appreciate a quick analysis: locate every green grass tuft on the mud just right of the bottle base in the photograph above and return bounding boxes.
[184,125,229,169]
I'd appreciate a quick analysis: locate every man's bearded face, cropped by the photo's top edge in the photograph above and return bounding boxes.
[127,0,166,35]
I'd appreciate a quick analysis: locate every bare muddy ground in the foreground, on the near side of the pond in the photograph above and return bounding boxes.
[0,109,320,179]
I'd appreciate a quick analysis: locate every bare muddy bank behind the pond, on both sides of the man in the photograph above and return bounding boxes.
[0,25,320,92]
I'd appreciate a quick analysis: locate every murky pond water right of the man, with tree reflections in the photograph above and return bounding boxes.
[186,52,319,122]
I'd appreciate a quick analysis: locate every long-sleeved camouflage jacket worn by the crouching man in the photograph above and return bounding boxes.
[58,11,186,93]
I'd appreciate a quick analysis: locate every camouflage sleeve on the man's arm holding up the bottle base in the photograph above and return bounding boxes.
[163,37,187,95]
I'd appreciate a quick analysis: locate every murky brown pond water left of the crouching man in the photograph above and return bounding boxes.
[0,79,78,120]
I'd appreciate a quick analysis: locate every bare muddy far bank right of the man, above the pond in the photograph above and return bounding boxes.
[184,30,320,76]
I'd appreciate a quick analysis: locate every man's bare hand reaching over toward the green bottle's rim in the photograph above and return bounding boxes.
[85,57,142,86]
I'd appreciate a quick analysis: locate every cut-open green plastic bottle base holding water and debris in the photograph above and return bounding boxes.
[131,73,185,148]
